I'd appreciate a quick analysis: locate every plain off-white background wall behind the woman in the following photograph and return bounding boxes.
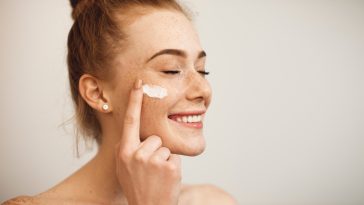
[0,0,364,205]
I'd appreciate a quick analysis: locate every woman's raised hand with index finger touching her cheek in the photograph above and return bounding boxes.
[115,80,181,205]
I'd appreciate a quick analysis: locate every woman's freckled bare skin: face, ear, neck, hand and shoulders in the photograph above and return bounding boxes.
[5,10,236,205]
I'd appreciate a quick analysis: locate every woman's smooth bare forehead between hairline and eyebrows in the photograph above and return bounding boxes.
[124,9,201,56]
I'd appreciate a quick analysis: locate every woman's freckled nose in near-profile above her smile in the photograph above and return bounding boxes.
[186,70,211,108]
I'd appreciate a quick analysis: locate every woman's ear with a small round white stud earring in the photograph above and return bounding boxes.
[78,74,112,113]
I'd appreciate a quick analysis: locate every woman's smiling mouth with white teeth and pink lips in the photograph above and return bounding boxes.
[168,112,205,129]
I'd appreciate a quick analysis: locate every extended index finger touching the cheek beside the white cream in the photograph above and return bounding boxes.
[120,79,143,148]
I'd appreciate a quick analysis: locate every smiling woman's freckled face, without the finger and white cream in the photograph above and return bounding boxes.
[111,10,211,156]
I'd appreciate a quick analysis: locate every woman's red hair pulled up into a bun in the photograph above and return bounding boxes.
[67,0,190,144]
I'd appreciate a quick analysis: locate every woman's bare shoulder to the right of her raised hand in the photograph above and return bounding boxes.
[179,184,238,205]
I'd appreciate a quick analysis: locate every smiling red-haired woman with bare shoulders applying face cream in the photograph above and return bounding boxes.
[5,0,236,205]
